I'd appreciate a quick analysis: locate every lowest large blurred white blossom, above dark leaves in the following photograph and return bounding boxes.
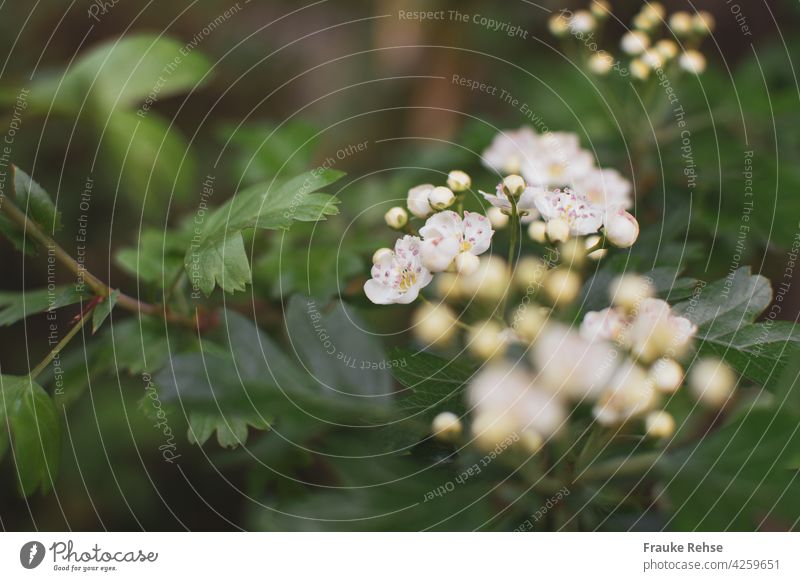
[467,362,567,443]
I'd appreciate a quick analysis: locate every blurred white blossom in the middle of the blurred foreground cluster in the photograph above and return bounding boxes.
[531,323,618,401]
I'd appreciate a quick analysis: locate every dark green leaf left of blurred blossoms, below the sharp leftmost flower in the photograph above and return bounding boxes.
[392,348,475,418]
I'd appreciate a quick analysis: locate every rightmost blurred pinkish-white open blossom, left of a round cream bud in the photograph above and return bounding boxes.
[623,298,697,361]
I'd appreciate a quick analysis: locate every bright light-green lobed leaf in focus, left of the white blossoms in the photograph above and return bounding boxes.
[184,169,344,296]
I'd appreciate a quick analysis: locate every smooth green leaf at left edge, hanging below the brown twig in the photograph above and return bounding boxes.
[0,375,61,496]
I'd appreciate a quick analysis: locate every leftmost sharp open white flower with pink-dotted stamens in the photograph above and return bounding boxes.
[364,236,433,305]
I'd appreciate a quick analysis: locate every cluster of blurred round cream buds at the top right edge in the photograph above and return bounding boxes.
[549,0,715,80]
